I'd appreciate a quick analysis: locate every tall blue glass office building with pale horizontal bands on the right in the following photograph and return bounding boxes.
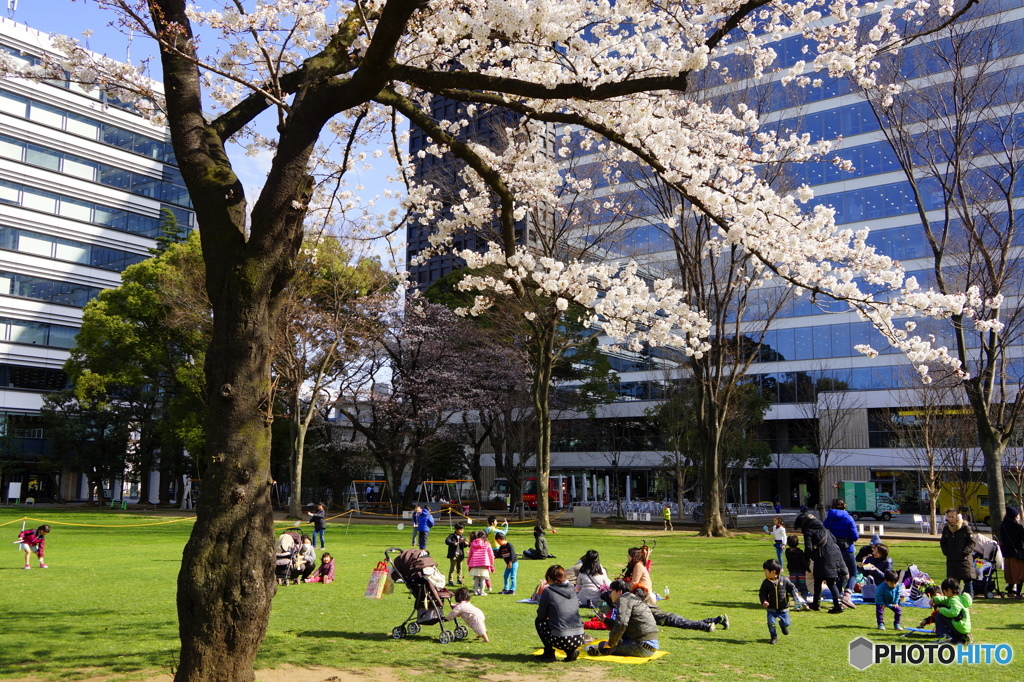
[552,0,1024,509]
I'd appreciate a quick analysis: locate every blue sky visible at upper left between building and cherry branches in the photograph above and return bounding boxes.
[11,0,404,266]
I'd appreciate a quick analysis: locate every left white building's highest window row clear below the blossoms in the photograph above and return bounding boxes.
[0,89,175,164]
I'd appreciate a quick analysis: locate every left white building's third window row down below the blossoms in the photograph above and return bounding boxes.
[0,180,193,238]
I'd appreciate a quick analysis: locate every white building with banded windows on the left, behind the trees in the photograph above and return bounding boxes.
[0,18,195,500]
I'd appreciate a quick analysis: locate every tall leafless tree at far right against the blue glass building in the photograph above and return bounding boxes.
[868,5,1024,518]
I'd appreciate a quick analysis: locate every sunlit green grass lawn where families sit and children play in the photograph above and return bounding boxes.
[0,508,1024,681]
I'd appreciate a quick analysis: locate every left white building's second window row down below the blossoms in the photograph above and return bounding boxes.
[0,135,191,207]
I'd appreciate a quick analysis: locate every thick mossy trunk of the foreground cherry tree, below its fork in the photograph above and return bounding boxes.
[175,270,276,682]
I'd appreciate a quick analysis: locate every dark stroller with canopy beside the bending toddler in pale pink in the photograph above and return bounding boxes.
[384,547,469,644]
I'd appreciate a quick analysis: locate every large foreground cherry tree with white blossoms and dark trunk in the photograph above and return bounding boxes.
[0,0,983,681]
